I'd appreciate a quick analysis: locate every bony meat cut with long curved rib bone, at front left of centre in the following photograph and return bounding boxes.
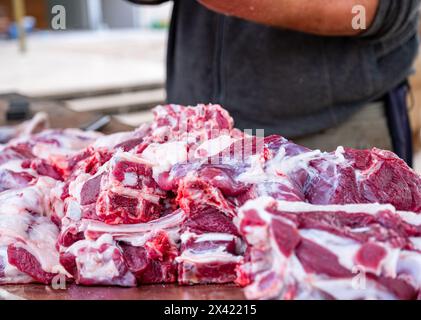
[59,210,185,286]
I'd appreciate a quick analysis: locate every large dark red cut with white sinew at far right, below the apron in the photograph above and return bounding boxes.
[267,137,421,212]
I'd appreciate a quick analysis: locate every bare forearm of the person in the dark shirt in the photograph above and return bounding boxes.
[199,0,381,36]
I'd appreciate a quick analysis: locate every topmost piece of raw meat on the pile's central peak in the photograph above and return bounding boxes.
[136,105,241,180]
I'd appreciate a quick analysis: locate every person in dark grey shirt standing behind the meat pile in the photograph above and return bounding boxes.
[130,0,420,164]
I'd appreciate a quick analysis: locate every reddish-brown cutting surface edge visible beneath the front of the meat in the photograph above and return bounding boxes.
[0,284,245,300]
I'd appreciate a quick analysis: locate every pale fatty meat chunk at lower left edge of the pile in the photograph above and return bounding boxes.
[0,178,65,284]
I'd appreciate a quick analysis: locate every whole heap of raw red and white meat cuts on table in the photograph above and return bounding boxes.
[0,105,421,299]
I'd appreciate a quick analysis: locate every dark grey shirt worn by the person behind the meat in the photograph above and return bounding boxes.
[130,0,420,138]
